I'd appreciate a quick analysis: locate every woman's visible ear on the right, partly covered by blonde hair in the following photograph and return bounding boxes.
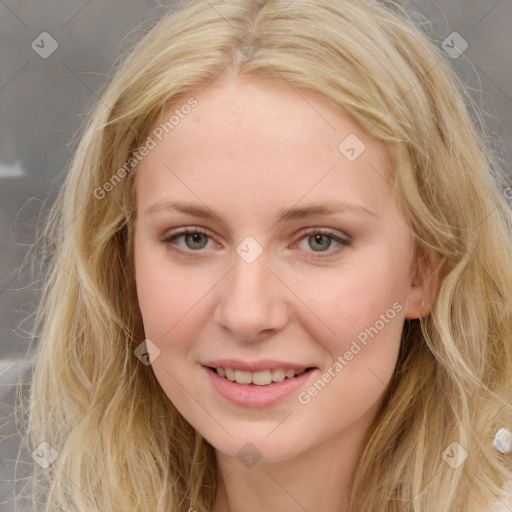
[405,248,441,320]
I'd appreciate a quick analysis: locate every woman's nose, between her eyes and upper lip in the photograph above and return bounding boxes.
[215,246,289,341]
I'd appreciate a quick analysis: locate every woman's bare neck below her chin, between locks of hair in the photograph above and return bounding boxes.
[214,410,376,512]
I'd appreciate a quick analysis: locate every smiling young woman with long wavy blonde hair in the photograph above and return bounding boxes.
[11,0,512,512]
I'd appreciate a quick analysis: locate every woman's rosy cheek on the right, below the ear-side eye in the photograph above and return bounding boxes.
[299,262,404,422]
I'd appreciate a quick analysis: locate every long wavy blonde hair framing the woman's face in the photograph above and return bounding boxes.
[11,0,512,512]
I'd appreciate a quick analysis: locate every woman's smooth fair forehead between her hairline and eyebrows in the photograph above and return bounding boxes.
[137,79,390,218]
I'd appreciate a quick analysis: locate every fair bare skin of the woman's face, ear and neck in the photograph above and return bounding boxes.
[134,72,438,512]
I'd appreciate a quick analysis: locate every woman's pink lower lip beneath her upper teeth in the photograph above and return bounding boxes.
[203,366,316,407]
